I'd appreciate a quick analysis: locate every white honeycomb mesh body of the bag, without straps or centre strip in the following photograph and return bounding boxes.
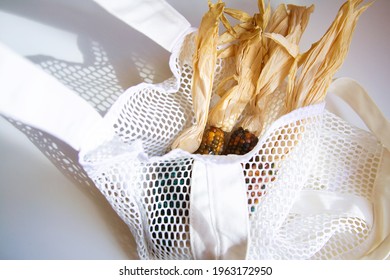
[80,33,382,259]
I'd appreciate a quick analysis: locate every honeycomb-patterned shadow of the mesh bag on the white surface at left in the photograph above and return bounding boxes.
[1,38,150,258]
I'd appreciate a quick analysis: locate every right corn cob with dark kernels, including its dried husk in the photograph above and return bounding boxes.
[221,5,313,158]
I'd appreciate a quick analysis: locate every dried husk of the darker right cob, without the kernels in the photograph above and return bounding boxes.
[241,5,314,136]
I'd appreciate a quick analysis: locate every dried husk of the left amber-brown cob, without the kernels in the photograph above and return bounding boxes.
[208,1,270,132]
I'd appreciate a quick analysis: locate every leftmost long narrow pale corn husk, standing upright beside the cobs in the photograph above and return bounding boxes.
[172,1,225,153]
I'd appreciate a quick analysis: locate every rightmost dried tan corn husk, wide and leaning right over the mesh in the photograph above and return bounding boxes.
[286,0,370,112]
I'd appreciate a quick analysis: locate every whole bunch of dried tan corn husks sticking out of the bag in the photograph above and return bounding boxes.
[172,0,368,152]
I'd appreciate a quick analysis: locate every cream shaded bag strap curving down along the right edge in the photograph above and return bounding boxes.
[329,78,390,259]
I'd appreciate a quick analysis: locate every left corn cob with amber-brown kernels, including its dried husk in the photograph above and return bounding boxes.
[197,1,264,155]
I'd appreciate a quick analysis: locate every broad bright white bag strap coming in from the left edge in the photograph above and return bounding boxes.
[0,43,102,150]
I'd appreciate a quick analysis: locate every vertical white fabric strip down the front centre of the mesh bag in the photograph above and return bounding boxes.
[190,160,249,260]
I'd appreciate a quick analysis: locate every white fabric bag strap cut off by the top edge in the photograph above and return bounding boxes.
[94,0,191,52]
